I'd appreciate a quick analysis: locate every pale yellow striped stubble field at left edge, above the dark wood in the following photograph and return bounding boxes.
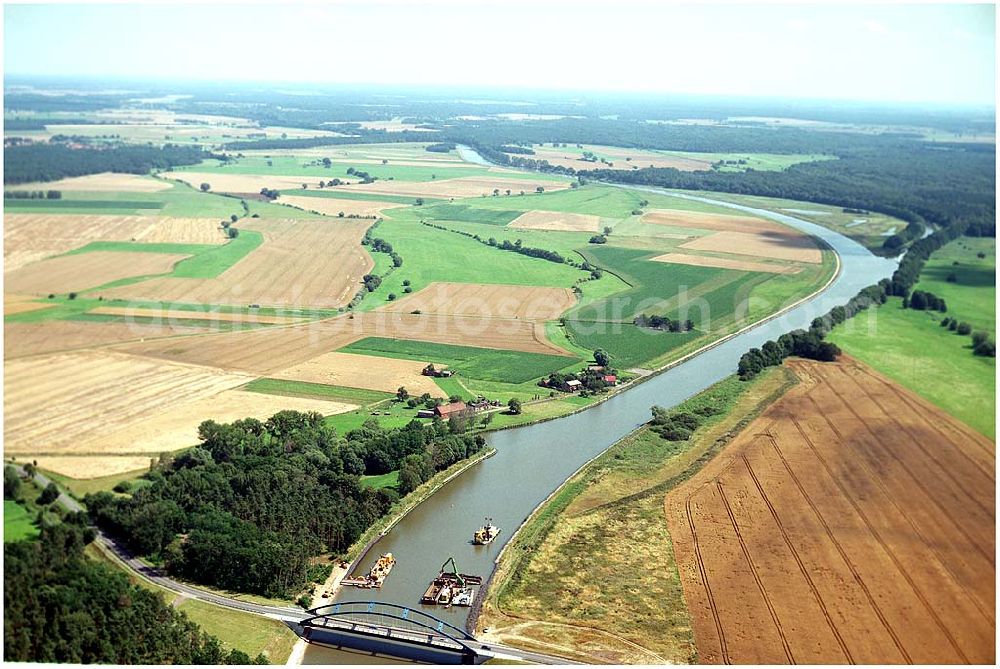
[4,351,253,455]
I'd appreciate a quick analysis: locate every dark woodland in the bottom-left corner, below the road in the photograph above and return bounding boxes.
[3,516,267,664]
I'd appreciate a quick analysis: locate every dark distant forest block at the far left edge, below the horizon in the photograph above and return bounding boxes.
[3,143,211,184]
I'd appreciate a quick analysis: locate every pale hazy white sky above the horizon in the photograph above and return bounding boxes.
[4,0,996,104]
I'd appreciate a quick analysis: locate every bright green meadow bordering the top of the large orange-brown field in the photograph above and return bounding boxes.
[828,297,996,439]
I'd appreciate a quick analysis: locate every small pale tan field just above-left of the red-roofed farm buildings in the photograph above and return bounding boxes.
[272,352,441,396]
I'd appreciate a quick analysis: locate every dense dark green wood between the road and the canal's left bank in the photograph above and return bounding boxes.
[85,411,485,597]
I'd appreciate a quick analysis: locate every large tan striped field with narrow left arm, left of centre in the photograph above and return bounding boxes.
[96,219,374,308]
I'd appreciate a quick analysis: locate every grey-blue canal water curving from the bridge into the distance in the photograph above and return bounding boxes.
[305,189,897,664]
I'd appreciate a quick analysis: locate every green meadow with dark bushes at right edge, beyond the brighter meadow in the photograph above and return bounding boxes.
[914,237,997,333]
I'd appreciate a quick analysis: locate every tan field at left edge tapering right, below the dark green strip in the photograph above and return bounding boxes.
[3,251,189,295]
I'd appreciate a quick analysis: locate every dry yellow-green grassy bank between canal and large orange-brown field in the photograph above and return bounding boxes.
[476,367,796,664]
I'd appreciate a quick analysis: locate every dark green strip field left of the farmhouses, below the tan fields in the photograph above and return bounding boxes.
[340,337,579,384]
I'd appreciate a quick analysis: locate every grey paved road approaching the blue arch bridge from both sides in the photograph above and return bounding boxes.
[12,463,575,664]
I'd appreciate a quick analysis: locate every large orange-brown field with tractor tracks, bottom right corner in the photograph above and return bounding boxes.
[666,356,996,664]
